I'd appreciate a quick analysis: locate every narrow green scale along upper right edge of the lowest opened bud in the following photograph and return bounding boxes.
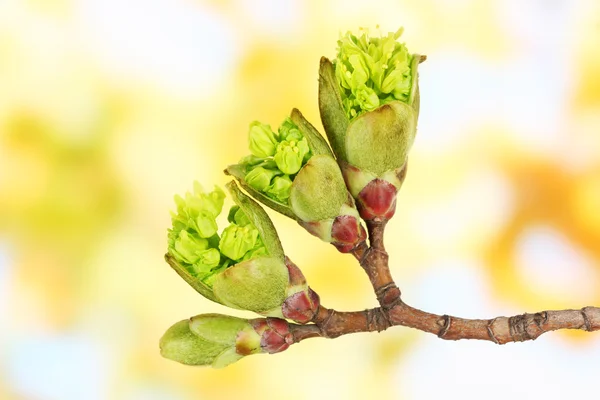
[225,181,285,260]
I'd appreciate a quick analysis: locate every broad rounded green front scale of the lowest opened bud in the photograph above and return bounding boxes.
[213,257,289,314]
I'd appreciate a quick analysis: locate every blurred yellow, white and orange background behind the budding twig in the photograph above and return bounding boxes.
[0,0,600,400]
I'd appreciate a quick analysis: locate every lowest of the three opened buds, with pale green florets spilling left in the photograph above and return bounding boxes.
[165,182,319,323]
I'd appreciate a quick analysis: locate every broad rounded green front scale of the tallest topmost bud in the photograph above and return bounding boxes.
[346,101,417,175]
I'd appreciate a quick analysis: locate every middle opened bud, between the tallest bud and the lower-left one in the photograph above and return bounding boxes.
[225,109,366,253]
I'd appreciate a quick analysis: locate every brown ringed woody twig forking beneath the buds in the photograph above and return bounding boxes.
[290,217,600,344]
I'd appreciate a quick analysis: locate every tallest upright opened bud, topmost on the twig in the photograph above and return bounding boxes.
[319,29,425,221]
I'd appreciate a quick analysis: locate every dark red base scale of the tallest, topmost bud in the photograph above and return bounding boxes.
[356,178,398,221]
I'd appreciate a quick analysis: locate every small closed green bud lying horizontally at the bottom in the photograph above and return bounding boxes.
[159,314,294,368]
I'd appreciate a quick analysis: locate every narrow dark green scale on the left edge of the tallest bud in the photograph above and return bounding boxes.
[319,57,350,160]
